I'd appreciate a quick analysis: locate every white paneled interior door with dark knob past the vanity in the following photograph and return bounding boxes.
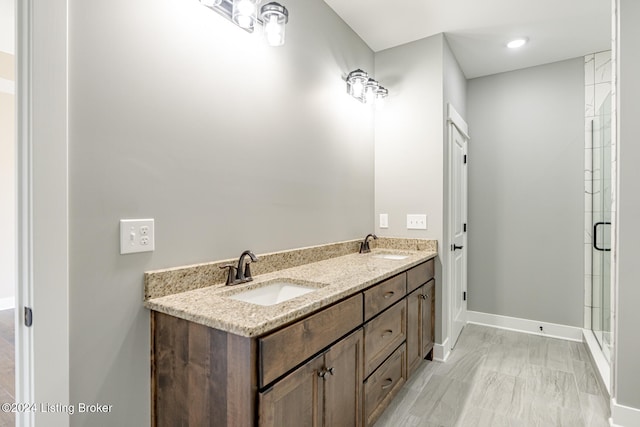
[448,105,469,348]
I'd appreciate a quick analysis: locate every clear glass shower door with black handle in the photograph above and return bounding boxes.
[591,93,612,361]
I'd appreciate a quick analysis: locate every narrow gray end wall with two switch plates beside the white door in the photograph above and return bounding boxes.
[375,34,447,343]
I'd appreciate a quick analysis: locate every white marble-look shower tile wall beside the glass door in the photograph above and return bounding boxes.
[584,51,615,329]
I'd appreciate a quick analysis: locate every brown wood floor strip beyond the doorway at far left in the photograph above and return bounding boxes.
[0,310,15,427]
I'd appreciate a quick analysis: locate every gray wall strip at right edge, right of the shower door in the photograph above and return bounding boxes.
[614,0,640,412]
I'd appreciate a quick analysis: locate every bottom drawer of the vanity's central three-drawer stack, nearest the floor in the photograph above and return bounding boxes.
[364,344,407,426]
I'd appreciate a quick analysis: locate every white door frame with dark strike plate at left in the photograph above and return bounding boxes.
[14,0,70,427]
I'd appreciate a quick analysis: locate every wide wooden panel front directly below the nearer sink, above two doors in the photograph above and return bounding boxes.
[258,294,362,387]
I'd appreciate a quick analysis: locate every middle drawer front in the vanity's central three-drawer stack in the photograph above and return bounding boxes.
[364,299,407,378]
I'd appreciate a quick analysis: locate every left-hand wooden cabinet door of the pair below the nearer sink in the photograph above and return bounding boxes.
[259,354,324,427]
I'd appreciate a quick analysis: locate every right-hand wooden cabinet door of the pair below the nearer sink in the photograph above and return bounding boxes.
[322,329,364,427]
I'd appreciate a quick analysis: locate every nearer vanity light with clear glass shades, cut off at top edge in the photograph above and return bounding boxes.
[200,0,289,46]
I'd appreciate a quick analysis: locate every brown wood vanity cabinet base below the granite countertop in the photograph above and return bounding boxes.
[151,259,435,427]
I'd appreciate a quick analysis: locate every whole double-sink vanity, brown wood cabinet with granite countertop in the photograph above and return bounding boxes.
[145,239,436,426]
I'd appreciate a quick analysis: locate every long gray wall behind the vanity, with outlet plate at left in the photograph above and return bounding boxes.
[69,0,374,426]
